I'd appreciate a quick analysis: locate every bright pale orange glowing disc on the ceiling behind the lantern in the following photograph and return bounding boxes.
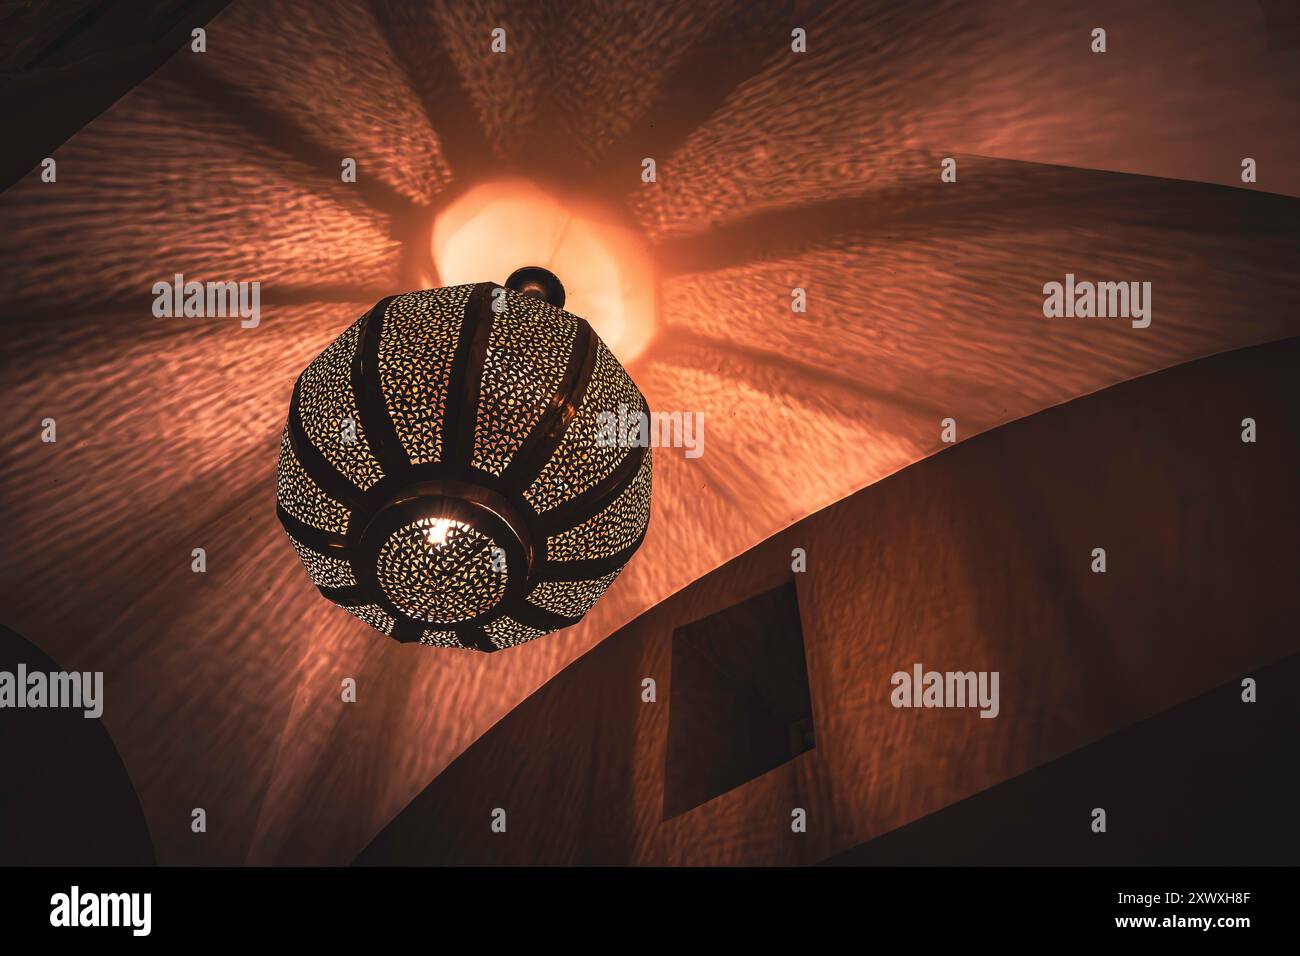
[433,179,655,364]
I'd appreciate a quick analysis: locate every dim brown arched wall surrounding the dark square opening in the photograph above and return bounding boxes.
[353,338,1300,866]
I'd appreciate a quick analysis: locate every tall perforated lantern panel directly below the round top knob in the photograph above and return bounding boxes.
[472,293,579,475]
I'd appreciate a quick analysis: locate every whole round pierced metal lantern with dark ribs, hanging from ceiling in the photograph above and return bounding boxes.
[276,269,651,652]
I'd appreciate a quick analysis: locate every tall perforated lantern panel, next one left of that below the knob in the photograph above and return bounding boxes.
[378,285,473,464]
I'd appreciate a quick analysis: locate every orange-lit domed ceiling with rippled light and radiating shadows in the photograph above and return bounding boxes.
[0,0,1300,862]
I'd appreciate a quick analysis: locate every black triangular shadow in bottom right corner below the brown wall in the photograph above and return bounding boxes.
[827,654,1300,866]
